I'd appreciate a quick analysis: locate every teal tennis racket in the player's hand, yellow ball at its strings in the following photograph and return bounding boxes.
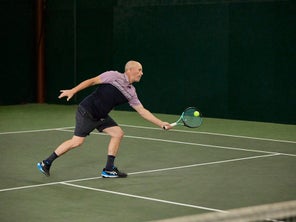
[163,107,202,129]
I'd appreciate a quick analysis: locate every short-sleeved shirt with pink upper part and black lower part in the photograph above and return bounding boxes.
[80,71,141,120]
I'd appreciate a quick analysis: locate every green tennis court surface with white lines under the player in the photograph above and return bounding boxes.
[0,104,296,222]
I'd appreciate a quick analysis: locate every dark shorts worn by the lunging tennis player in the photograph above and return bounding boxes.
[74,106,118,137]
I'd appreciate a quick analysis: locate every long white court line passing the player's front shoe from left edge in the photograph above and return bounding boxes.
[0,153,281,192]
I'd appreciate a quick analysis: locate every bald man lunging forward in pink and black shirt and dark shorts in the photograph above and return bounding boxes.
[37,61,171,178]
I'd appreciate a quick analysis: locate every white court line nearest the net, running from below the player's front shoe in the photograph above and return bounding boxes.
[60,182,227,213]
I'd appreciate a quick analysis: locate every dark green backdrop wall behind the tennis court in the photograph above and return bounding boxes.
[0,0,296,124]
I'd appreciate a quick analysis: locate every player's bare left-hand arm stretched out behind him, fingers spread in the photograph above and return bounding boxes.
[59,76,101,101]
